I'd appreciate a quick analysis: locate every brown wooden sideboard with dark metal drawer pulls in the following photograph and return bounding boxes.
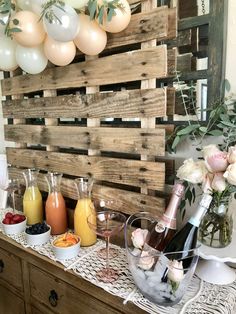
[0,234,145,314]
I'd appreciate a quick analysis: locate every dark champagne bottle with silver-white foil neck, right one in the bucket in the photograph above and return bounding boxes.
[164,194,212,268]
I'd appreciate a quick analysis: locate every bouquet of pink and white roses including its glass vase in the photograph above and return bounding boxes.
[177,144,236,247]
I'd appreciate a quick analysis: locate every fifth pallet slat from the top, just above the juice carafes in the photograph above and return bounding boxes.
[6,148,165,191]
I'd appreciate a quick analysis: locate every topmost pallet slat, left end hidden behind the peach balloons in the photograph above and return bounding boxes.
[106,6,170,49]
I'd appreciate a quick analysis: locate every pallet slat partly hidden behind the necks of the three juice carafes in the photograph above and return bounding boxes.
[9,167,165,216]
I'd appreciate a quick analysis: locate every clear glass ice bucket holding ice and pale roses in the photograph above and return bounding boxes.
[125,212,198,306]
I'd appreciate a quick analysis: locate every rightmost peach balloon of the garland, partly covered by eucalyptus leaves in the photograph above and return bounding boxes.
[100,0,131,33]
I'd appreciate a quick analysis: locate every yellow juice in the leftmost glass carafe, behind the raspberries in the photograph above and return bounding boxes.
[23,186,43,225]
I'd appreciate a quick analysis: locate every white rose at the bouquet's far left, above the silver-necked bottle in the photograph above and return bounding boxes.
[177,158,208,184]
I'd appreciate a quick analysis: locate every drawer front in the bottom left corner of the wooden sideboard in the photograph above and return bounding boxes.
[0,285,25,314]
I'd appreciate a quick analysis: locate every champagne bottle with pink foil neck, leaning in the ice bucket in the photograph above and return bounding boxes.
[146,183,184,251]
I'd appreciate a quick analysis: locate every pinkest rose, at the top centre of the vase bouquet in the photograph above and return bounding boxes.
[205,151,228,173]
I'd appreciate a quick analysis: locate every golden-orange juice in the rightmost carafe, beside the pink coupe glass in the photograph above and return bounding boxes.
[74,198,97,246]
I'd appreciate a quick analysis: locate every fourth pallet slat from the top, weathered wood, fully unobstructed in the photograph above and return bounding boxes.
[5,125,165,156]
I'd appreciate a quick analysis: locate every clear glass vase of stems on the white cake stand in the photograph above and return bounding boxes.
[198,196,233,248]
